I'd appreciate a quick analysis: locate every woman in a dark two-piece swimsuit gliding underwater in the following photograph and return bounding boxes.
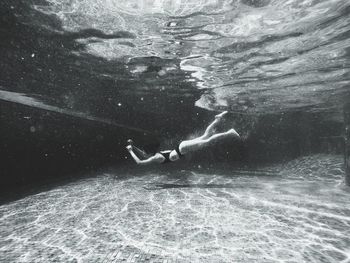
[126,111,240,165]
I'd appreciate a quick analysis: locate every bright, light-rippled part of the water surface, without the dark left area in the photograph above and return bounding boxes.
[30,0,350,116]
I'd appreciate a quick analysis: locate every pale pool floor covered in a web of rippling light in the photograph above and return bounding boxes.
[0,155,350,263]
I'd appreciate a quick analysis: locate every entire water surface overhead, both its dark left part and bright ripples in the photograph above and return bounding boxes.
[0,0,350,135]
